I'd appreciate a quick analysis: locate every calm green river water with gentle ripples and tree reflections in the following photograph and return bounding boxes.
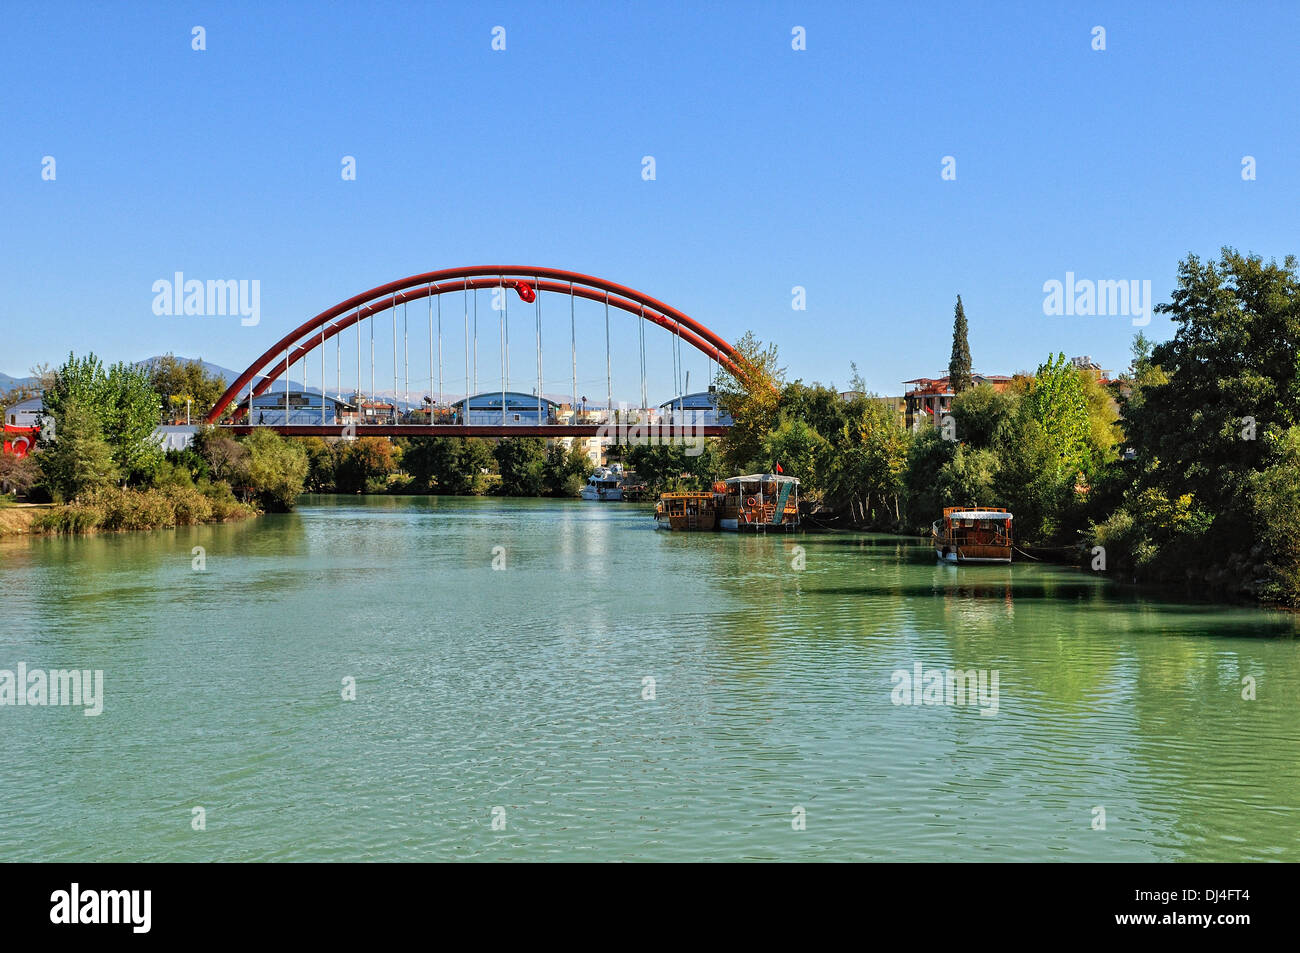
[0,497,1300,861]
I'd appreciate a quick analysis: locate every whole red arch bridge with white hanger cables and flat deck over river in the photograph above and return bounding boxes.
[205,265,746,438]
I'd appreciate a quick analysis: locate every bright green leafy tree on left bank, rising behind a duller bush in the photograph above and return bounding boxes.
[42,354,163,484]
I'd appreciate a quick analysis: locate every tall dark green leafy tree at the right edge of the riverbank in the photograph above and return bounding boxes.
[1125,248,1300,601]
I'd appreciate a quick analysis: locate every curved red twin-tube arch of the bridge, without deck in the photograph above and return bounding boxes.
[204,265,746,424]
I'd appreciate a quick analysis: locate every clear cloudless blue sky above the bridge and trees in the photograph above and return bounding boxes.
[0,3,1300,400]
